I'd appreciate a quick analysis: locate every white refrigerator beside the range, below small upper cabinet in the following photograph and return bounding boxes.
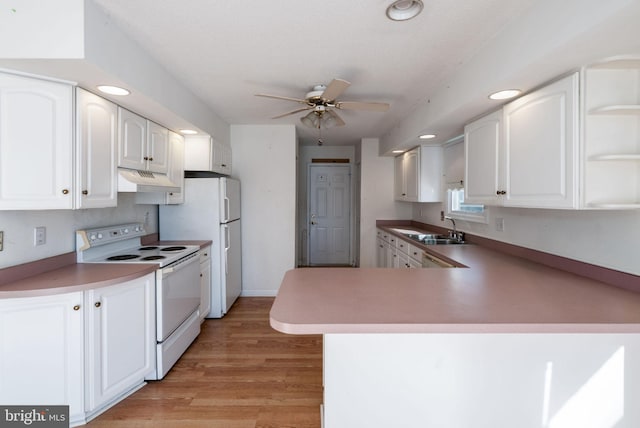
[159,177,242,318]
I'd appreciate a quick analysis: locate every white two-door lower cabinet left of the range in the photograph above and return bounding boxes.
[0,273,155,426]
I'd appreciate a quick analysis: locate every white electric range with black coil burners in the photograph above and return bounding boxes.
[76,223,200,380]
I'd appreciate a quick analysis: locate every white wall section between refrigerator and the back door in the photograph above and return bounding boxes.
[231,125,297,296]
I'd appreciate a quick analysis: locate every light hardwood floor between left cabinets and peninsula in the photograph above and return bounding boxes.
[86,297,322,428]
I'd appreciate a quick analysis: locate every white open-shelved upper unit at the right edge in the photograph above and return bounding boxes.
[582,58,640,209]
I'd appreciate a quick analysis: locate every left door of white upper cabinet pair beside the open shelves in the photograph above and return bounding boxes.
[464,110,502,205]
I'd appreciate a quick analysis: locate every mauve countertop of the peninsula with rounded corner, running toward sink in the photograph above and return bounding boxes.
[270,231,640,334]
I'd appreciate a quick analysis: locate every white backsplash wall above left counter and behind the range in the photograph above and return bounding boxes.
[0,193,158,268]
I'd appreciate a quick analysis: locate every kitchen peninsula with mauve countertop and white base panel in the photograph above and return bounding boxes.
[271,236,640,428]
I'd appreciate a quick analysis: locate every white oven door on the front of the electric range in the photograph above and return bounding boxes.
[156,252,200,342]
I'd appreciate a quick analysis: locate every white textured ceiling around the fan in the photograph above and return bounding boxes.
[95,0,536,144]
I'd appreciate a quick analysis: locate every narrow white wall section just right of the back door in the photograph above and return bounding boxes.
[360,138,412,267]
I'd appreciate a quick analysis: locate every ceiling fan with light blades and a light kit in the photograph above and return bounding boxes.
[256,79,389,129]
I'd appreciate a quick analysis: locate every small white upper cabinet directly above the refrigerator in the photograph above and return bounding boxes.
[184,135,231,175]
